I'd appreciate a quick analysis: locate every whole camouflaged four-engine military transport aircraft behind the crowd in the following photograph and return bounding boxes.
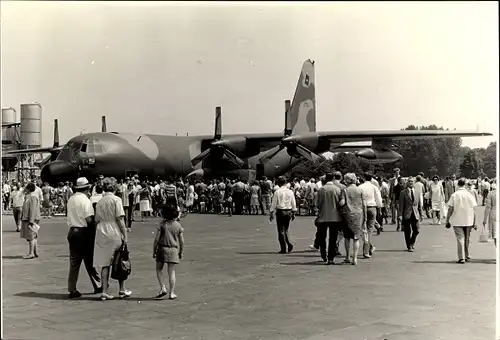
[1,60,491,183]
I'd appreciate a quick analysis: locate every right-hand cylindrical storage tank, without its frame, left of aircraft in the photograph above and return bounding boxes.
[21,104,42,148]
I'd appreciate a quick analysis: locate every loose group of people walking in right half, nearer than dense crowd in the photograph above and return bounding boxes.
[270,168,497,265]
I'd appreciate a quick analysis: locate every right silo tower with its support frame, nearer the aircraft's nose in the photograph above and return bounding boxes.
[17,103,42,181]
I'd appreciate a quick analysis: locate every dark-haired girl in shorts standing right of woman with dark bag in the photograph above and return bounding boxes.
[153,203,184,300]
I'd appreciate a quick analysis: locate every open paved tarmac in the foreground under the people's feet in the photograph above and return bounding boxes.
[2,208,495,340]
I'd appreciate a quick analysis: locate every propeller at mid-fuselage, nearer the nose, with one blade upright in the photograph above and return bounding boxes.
[191,106,245,168]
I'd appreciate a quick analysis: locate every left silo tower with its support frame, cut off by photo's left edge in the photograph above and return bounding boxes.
[2,107,21,179]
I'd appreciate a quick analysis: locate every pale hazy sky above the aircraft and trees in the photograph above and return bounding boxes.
[1,1,499,147]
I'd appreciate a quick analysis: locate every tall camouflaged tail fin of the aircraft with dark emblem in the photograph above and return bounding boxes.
[289,59,316,134]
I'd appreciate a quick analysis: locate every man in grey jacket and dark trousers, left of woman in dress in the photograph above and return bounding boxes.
[316,173,342,264]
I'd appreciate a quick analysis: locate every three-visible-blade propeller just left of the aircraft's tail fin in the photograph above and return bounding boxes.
[259,100,320,164]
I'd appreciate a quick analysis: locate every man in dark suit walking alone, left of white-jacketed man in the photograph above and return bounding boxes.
[398,177,422,252]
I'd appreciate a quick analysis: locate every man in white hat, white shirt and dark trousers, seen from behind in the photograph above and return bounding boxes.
[66,177,102,299]
